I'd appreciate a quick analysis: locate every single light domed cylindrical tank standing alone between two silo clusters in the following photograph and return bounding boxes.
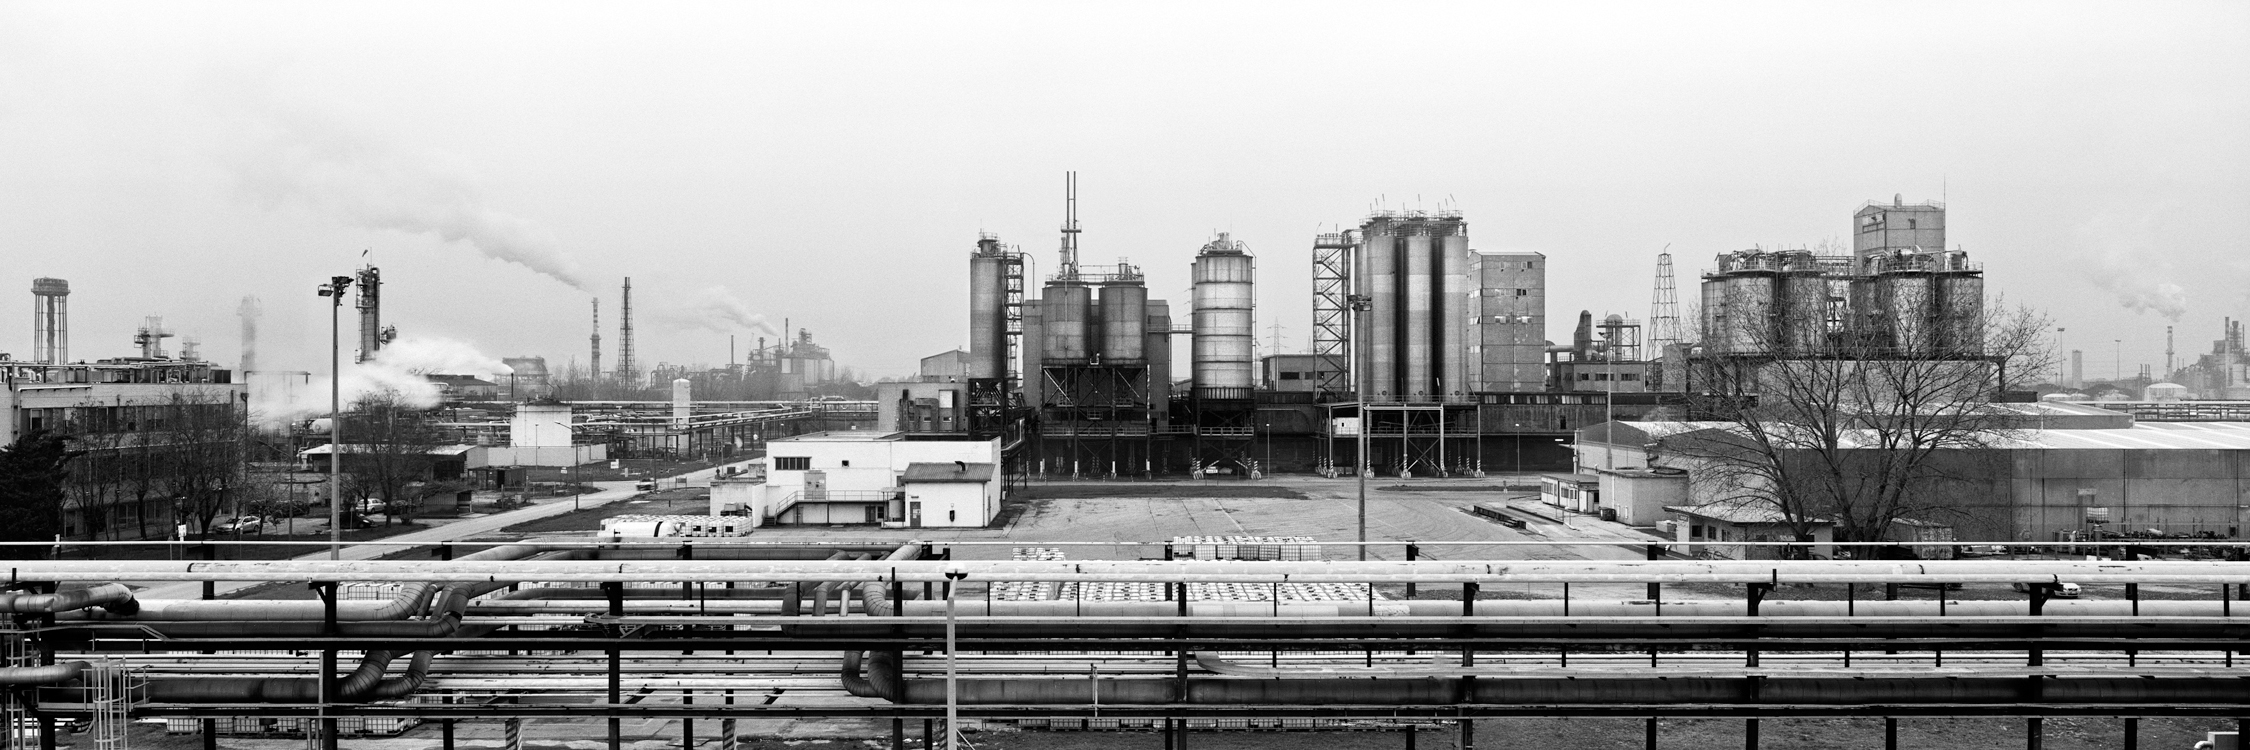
[1193,234,1258,399]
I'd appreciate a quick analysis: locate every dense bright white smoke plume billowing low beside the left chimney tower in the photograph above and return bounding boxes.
[250,336,515,426]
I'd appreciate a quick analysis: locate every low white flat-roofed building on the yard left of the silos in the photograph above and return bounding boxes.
[711,430,1001,527]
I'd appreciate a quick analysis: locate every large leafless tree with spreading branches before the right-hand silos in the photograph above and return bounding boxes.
[1658,255,2048,541]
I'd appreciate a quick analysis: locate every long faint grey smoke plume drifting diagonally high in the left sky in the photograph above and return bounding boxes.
[230,103,587,288]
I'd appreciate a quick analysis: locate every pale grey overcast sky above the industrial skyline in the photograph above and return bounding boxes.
[0,0,2250,376]
